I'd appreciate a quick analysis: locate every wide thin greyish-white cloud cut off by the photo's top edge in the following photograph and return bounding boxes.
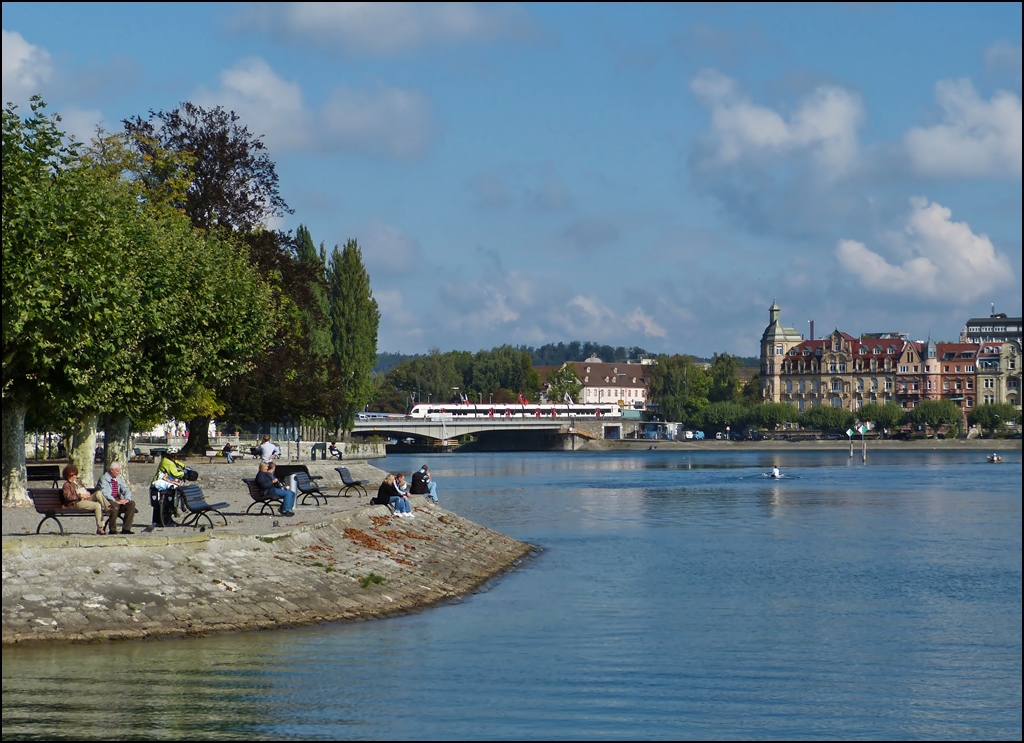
[242,2,536,56]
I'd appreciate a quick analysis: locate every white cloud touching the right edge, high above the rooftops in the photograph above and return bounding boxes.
[904,79,1021,178]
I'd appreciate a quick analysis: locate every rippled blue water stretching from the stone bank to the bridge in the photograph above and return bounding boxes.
[3,450,1021,740]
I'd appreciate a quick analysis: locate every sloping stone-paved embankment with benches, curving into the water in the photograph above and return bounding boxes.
[3,465,531,645]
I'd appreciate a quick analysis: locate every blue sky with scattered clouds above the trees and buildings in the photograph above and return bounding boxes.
[3,3,1022,356]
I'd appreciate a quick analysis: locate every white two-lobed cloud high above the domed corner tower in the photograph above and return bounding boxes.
[690,70,864,179]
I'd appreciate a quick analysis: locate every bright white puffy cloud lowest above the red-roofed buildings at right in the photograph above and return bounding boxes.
[836,198,1019,304]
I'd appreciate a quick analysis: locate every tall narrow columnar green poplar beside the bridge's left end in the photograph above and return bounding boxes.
[328,239,381,432]
